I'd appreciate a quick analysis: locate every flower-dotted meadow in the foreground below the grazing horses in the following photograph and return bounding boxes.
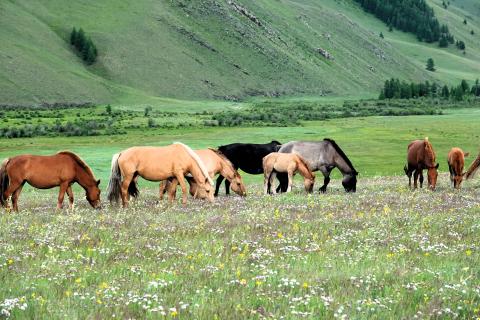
[0,175,480,319]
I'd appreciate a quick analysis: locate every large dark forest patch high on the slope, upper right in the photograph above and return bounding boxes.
[355,0,455,47]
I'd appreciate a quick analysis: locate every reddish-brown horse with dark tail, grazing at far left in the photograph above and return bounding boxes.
[0,151,100,211]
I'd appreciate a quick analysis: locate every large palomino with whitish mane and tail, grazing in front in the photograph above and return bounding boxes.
[107,142,213,207]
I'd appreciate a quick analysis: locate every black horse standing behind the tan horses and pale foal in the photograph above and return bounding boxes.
[215,140,282,196]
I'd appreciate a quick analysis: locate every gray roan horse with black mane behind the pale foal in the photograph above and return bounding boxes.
[277,139,358,192]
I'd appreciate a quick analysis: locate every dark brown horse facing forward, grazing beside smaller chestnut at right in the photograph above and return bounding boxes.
[403,138,439,190]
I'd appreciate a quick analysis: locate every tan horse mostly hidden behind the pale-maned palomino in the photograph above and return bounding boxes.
[160,148,247,200]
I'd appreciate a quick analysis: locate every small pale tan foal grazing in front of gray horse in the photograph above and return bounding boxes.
[263,152,315,194]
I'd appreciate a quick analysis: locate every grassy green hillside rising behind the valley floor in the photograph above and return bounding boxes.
[0,0,480,104]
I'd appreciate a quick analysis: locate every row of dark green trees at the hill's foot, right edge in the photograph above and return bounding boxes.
[379,78,480,101]
